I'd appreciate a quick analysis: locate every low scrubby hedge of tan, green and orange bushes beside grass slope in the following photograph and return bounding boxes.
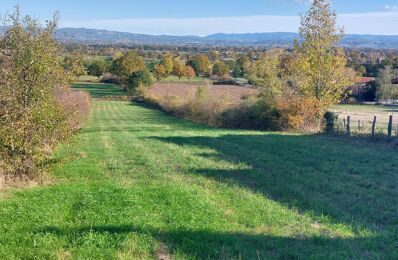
[144,86,321,132]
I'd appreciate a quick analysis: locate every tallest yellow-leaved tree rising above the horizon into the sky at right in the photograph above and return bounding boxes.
[295,0,353,106]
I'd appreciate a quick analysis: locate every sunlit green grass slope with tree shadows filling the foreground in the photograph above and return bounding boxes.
[0,85,398,259]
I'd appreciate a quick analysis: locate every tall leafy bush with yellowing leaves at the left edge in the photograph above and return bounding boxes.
[0,10,90,178]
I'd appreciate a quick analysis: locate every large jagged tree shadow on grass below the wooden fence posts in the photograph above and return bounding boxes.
[153,134,398,234]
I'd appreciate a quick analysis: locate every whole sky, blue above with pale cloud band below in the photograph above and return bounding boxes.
[0,0,398,35]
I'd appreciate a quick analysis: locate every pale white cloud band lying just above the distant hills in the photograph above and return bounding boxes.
[61,12,398,35]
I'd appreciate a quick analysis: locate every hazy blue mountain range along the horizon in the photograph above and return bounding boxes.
[0,27,392,50]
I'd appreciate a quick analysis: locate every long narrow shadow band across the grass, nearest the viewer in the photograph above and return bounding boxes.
[35,224,382,259]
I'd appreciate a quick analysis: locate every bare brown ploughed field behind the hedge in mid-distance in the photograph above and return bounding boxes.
[148,84,257,103]
